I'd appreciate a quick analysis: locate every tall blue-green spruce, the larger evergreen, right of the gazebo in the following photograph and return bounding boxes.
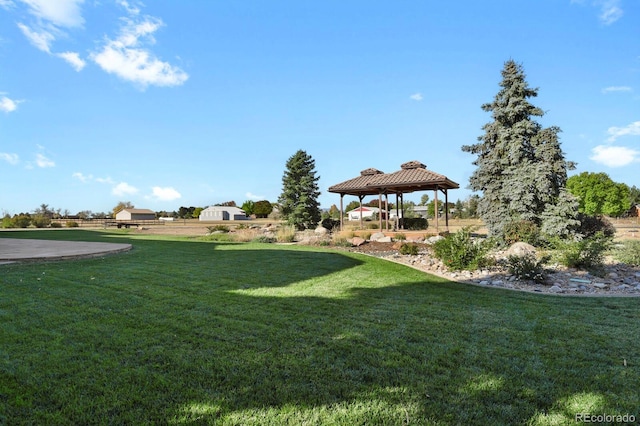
[462,60,578,238]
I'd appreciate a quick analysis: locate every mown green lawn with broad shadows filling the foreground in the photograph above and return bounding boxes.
[0,230,640,425]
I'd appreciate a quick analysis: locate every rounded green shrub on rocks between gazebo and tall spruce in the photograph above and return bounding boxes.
[433,227,492,270]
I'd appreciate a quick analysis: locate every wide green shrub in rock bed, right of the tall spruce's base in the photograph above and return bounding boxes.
[553,232,612,270]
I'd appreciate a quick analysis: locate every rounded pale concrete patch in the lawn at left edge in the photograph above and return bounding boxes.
[0,238,131,264]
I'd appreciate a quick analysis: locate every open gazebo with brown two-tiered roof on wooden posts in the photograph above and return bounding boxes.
[329,161,460,232]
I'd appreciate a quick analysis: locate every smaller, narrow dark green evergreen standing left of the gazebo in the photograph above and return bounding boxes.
[278,150,321,230]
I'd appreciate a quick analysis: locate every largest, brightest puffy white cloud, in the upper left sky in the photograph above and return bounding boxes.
[91,17,189,87]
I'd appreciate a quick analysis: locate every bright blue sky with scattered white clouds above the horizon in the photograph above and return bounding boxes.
[0,0,640,214]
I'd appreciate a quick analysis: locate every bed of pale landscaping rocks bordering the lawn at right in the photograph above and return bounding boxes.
[347,241,640,296]
